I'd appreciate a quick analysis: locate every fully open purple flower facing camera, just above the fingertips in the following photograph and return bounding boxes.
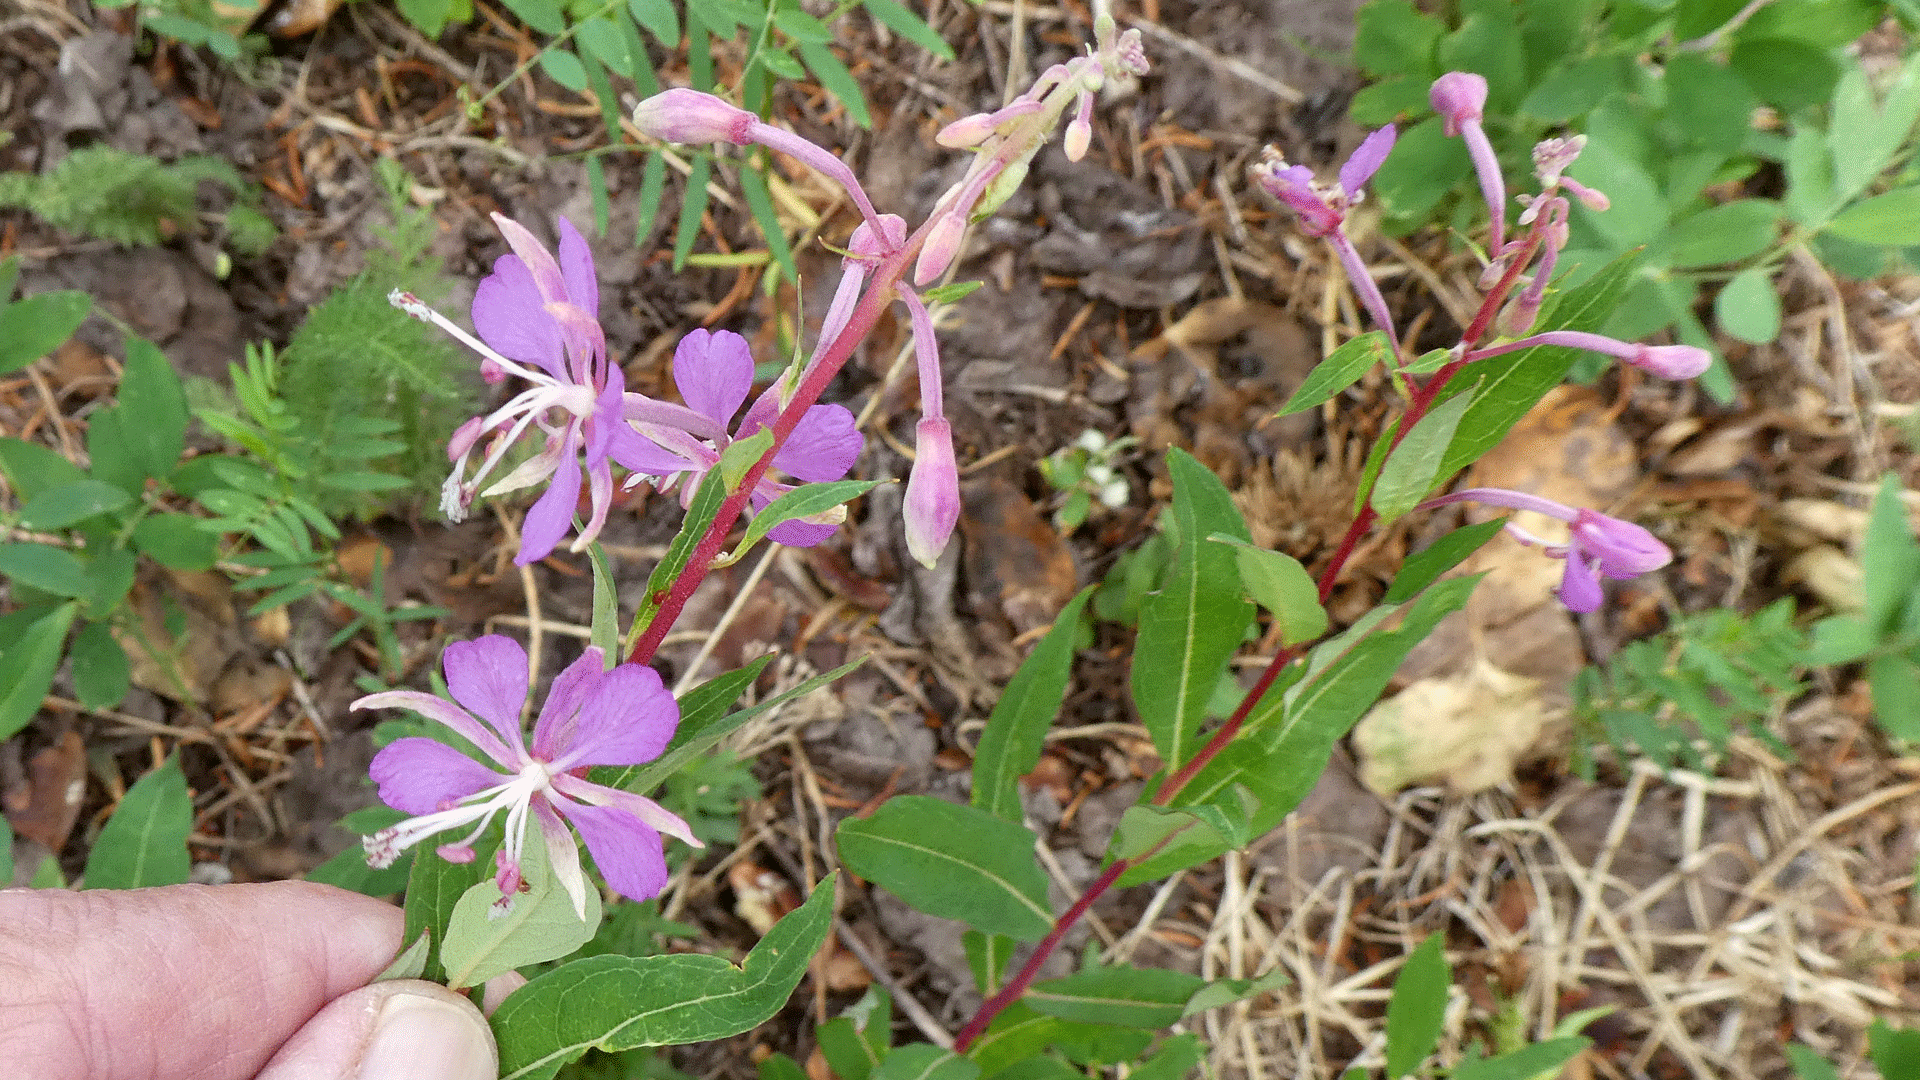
[353,634,703,915]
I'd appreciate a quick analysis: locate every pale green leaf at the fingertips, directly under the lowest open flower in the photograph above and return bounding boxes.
[440,836,601,990]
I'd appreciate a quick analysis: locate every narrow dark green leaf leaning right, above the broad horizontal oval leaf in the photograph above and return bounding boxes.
[972,586,1092,822]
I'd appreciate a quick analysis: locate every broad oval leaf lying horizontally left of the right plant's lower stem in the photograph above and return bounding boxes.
[835,796,1054,942]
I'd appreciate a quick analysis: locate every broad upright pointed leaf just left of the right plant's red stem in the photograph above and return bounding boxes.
[1131,450,1254,763]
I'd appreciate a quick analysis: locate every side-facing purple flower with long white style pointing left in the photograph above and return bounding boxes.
[390,213,652,567]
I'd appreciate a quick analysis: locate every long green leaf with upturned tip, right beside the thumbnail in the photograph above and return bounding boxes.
[493,878,833,1080]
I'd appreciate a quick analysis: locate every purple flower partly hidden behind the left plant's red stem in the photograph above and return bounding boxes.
[620,331,866,548]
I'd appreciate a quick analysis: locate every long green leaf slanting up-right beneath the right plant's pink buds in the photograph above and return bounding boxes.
[1434,249,1640,477]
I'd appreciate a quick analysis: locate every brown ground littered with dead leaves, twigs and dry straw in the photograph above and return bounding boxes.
[0,0,1920,1080]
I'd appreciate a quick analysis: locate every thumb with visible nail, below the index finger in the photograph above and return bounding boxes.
[259,980,499,1080]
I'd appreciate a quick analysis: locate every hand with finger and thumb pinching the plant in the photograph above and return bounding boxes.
[0,882,499,1080]
